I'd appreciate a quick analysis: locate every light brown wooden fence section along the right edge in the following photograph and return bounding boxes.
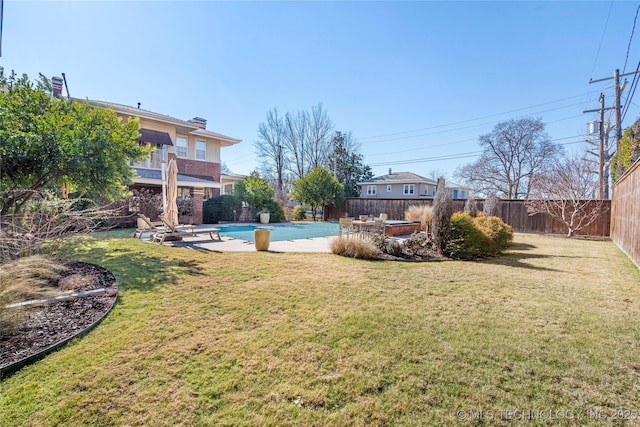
[611,160,640,267]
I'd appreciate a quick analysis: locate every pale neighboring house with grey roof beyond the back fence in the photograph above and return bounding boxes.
[357,169,469,199]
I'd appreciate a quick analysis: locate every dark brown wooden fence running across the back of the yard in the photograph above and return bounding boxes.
[323,198,611,237]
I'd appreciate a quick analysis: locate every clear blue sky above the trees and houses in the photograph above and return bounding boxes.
[0,0,640,179]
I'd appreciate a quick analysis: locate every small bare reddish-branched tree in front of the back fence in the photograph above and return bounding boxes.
[526,155,605,237]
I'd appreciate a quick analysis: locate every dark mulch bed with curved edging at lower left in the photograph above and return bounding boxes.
[0,262,116,367]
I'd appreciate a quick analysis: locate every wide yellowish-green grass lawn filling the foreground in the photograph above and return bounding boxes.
[0,234,640,426]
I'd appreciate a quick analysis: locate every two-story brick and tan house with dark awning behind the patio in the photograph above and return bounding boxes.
[87,99,245,224]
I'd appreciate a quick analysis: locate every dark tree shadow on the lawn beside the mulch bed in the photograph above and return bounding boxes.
[61,238,202,291]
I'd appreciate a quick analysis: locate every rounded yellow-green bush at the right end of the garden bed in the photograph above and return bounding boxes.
[445,212,513,260]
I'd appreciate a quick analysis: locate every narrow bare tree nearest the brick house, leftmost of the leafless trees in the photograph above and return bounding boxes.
[254,108,288,193]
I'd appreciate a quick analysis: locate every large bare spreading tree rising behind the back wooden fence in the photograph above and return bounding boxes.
[456,118,563,199]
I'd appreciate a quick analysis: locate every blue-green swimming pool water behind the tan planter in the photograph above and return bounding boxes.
[218,222,338,242]
